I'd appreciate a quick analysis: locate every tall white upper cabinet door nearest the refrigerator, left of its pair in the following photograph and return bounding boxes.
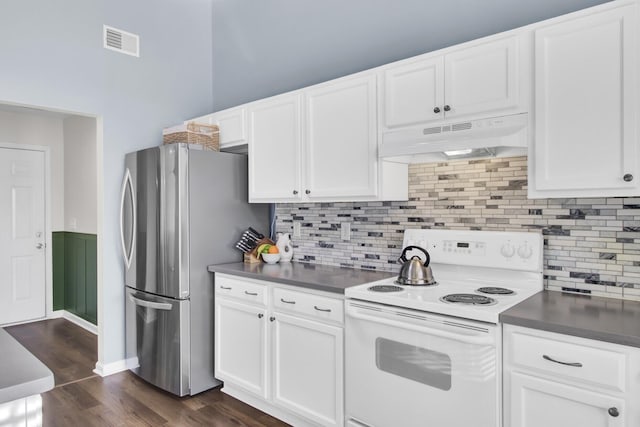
[249,94,302,202]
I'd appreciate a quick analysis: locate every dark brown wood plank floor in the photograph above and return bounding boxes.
[5,319,288,427]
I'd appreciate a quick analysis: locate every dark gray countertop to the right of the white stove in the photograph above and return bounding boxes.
[500,291,640,347]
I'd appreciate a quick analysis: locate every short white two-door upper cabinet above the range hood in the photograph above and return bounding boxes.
[382,33,530,130]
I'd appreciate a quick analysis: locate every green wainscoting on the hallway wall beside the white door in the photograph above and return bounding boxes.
[52,231,98,325]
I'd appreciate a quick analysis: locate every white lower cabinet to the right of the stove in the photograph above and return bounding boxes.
[503,325,640,427]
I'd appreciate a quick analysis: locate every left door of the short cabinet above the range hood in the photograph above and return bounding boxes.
[382,56,444,129]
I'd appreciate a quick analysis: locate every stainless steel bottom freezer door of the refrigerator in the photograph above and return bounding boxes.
[126,288,190,396]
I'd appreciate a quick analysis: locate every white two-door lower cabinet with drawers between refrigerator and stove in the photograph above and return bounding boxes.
[215,274,344,426]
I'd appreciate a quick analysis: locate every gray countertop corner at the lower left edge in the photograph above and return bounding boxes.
[0,328,54,404]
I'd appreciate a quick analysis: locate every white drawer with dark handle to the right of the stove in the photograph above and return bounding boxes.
[509,332,626,391]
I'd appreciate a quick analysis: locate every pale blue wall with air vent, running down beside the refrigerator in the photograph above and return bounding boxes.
[0,0,213,365]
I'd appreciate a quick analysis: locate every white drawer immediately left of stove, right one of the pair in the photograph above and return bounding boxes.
[273,288,344,324]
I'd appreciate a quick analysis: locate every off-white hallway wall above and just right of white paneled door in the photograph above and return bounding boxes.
[0,110,65,231]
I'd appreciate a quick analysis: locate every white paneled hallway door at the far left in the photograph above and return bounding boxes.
[0,148,45,325]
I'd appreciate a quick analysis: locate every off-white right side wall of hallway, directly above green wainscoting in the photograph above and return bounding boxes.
[63,116,98,234]
